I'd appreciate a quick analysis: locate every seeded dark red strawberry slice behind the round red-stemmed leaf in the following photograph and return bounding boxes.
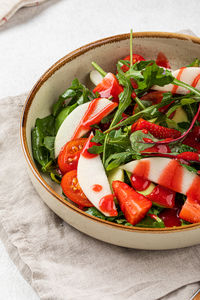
[131,118,181,139]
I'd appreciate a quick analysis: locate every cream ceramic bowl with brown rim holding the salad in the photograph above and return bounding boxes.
[21,32,200,250]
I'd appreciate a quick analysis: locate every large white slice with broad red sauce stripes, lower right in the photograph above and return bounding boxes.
[121,157,200,201]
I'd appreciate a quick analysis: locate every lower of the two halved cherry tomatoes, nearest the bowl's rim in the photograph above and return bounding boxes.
[61,170,93,207]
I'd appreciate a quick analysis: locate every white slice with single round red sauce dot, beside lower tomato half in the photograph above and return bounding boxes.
[77,135,117,217]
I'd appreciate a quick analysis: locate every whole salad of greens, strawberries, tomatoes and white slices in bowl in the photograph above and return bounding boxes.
[32,35,200,228]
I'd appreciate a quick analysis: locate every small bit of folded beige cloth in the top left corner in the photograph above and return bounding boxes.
[0,0,63,32]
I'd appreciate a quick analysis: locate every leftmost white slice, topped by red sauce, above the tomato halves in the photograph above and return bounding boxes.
[54,98,116,158]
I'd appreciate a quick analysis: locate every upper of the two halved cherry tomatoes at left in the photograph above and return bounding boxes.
[58,138,87,175]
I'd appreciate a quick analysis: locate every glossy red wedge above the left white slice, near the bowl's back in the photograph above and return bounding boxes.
[93,73,123,103]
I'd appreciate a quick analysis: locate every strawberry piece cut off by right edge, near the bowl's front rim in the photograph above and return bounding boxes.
[179,197,200,223]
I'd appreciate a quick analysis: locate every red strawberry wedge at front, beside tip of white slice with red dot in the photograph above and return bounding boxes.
[112,180,152,225]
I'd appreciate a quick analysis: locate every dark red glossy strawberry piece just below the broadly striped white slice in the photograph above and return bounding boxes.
[146,185,176,208]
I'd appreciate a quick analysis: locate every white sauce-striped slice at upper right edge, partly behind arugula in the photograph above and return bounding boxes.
[152,67,200,95]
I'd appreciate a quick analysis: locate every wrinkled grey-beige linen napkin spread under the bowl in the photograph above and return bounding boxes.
[0,95,200,300]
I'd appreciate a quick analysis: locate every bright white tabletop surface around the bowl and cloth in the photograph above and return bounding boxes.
[0,0,200,300]
